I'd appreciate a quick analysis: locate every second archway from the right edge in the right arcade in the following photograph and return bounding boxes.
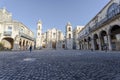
[100,31,108,50]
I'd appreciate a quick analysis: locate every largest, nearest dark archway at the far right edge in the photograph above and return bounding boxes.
[110,25,120,50]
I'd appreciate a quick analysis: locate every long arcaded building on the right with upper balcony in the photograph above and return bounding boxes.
[79,0,120,50]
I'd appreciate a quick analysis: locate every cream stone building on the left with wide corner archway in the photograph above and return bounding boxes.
[0,8,34,50]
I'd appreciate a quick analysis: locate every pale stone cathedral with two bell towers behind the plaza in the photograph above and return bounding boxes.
[36,21,73,49]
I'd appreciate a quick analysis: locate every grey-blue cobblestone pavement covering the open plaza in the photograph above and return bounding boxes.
[0,50,120,80]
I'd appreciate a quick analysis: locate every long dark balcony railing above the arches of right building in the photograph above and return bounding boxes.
[90,6,120,32]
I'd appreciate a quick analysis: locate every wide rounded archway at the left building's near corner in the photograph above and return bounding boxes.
[1,38,14,49]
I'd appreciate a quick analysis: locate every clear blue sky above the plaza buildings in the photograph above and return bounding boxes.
[0,0,110,35]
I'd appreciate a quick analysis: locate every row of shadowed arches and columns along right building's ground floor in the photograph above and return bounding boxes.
[79,25,120,51]
